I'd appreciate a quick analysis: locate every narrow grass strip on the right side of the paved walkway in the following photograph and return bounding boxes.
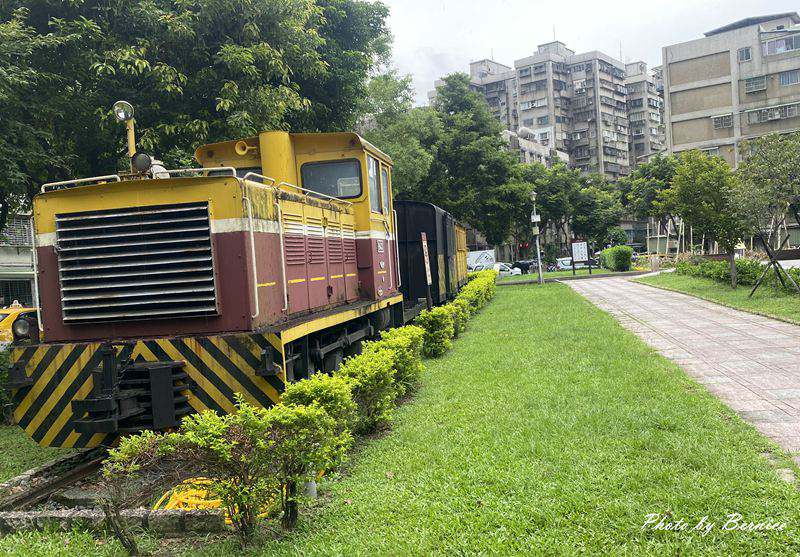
[636,273,800,324]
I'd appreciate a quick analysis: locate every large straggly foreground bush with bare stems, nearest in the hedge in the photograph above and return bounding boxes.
[103,395,343,546]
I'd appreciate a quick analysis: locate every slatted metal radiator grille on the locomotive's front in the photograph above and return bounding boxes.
[56,203,217,323]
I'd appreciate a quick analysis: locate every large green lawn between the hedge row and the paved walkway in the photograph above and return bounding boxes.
[0,284,800,557]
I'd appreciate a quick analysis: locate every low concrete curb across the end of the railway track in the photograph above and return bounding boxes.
[0,509,227,537]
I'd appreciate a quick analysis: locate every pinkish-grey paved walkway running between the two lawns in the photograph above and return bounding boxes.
[569,278,800,458]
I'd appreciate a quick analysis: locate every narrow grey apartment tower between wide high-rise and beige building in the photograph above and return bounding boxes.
[625,61,666,169]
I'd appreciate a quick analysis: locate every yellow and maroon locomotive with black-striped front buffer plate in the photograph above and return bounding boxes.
[9,128,466,447]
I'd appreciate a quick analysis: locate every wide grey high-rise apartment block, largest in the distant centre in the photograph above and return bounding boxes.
[460,41,630,180]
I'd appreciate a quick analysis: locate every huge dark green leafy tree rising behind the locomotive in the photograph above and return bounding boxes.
[0,0,389,226]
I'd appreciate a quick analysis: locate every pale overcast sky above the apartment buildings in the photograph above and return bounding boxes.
[383,0,800,104]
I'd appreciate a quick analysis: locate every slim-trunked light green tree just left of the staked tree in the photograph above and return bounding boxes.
[667,150,749,288]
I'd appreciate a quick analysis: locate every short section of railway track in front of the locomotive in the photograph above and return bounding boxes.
[0,449,106,511]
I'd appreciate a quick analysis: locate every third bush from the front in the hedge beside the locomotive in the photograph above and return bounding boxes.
[334,343,397,433]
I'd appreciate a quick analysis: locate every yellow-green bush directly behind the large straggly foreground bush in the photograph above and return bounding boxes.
[281,373,358,458]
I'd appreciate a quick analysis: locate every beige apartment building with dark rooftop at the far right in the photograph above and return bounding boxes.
[663,12,800,166]
